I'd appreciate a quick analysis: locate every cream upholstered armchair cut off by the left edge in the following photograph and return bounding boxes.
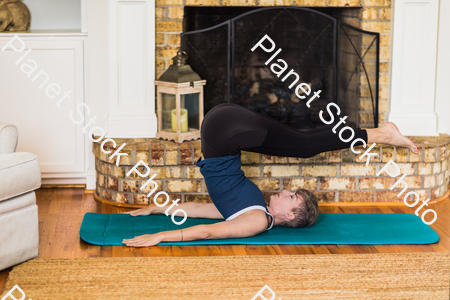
[0,122,41,270]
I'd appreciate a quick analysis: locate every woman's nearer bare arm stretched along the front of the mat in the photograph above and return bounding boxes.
[123,210,268,247]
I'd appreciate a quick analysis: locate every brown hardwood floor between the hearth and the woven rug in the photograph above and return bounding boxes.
[0,188,450,294]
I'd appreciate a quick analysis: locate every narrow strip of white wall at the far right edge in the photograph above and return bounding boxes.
[436,0,450,134]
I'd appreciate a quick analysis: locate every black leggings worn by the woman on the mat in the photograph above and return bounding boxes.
[201,103,367,158]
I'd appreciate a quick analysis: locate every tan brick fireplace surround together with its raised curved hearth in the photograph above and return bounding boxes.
[93,0,450,205]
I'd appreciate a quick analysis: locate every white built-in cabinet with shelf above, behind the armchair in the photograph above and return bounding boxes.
[0,0,88,184]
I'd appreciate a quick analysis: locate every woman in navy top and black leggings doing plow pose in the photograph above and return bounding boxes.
[123,103,418,247]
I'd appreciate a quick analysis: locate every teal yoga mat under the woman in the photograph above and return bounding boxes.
[80,213,439,245]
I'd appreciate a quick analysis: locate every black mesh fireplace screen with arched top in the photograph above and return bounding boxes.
[181,7,379,129]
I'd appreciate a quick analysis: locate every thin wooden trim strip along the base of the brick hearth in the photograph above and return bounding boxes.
[92,185,450,208]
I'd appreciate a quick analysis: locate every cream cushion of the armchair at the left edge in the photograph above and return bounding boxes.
[0,152,41,201]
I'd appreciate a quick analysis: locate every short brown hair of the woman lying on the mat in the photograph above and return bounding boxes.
[280,188,319,228]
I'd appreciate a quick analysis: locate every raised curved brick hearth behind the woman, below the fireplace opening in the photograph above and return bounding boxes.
[93,134,450,204]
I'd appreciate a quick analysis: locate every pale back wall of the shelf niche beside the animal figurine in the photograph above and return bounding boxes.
[23,0,81,29]
